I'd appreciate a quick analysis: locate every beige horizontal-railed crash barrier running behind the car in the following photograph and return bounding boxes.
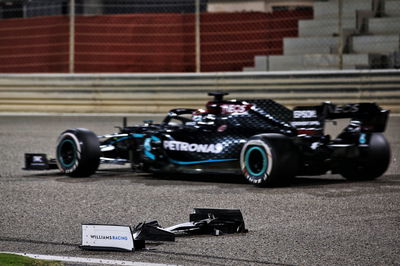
[0,70,400,113]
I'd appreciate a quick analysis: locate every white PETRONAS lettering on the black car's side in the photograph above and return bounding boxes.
[164,140,224,153]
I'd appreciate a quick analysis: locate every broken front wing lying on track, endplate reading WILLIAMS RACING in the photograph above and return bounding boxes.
[80,208,248,251]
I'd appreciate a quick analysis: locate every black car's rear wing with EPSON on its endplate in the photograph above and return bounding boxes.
[291,102,390,134]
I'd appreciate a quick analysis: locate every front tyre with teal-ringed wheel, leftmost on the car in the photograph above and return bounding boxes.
[56,128,101,177]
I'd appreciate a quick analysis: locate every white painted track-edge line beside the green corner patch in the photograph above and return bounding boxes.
[0,251,176,266]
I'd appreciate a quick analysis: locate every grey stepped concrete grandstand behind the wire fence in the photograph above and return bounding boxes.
[244,0,400,71]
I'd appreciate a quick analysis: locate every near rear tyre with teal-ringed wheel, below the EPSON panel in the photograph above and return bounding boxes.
[240,134,299,186]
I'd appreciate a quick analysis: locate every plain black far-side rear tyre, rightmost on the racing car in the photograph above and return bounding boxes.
[340,133,390,180]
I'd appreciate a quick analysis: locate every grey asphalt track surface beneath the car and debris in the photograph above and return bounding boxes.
[0,116,400,265]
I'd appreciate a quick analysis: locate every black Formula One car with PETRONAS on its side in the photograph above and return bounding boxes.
[26,92,390,186]
